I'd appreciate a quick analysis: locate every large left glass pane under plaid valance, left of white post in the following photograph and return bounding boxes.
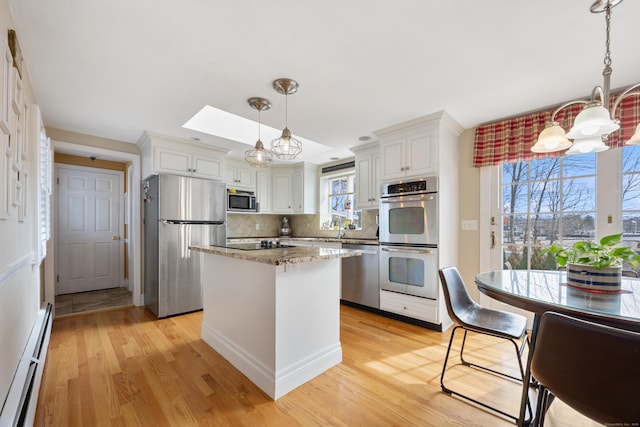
[502,154,596,269]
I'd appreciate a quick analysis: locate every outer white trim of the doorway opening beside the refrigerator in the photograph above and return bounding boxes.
[44,142,144,307]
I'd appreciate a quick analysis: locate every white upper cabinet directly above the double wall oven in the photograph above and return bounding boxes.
[376,122,438,181]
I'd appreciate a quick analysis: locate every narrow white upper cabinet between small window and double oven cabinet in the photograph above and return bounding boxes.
[351,143,380,209]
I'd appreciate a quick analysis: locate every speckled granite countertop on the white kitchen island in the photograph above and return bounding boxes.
[189,246,363,265]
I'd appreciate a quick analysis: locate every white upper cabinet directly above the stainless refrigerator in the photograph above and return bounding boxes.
[138,132,226,179]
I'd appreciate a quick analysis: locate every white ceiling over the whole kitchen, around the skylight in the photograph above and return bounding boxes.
[9,0,640,163]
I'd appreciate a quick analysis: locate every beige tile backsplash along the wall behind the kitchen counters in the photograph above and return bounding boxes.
[227,209,378,239]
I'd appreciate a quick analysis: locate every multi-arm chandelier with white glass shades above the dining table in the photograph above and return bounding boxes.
[531,0,640,154]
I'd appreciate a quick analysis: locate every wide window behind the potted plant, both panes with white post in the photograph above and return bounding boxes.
[501,146,640,269]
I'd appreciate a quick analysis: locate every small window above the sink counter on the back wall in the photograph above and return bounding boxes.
[320,171,362,230]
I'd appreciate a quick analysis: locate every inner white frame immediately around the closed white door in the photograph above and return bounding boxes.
[52,162,125,295]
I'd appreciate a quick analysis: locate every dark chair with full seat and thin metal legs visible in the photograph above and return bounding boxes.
[439,267,531,421]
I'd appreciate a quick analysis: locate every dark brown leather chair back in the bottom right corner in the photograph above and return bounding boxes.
[531,312,640,426]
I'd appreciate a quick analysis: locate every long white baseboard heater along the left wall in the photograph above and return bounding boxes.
[0,303,53,427]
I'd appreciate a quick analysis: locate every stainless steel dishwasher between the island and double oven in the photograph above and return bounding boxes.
[342,243,380,309]
